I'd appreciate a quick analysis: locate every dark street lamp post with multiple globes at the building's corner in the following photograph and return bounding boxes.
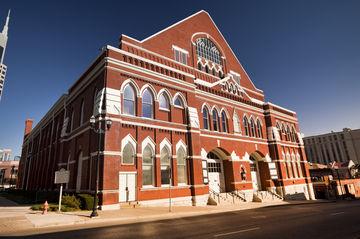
[90,115,112,218]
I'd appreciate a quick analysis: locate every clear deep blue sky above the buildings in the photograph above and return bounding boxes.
[0,0,360,157]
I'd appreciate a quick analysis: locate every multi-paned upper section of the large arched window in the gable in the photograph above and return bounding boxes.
[196,38,221,65]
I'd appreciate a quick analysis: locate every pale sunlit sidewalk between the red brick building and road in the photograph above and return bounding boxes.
[0,198,329,235]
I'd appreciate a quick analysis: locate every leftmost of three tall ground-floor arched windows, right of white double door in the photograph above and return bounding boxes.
[142,145,155,186]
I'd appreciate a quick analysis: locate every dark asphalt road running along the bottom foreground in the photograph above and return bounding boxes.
[2,201,360,239]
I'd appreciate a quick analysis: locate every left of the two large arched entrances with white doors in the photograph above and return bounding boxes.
[207,151,225,193]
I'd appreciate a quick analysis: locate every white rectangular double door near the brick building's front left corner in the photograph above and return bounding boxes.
[119,172,136,202]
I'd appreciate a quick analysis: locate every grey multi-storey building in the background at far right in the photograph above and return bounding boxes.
[304,128,360,164]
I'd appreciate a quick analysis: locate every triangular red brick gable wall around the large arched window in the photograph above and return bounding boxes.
[121,10,264,100]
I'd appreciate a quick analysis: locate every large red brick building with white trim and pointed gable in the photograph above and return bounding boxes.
[18,11,314,209]
